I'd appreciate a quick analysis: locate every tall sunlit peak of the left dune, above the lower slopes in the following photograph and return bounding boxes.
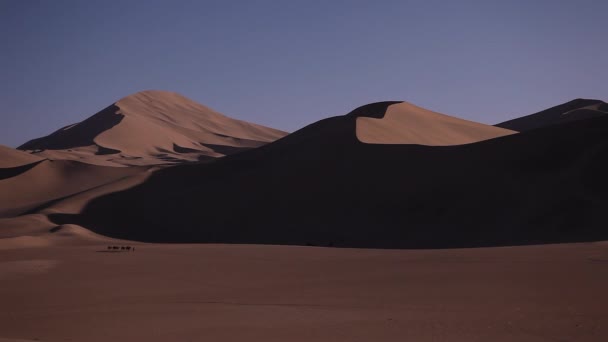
[19,90,286,166]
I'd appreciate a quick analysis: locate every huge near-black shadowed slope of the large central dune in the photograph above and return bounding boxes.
[51,102,608,248]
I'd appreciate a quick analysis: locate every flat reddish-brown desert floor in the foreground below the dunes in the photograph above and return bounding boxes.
[0,242,608,341]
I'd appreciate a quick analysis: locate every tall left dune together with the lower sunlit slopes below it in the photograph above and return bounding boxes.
[0,91,286,222]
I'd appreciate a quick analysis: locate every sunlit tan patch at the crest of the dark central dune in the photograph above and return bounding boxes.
[357,102,516,146]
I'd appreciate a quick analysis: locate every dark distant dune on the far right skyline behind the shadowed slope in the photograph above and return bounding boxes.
[496,99,608,132]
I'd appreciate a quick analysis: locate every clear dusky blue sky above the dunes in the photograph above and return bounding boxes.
[0,0,608,146]
